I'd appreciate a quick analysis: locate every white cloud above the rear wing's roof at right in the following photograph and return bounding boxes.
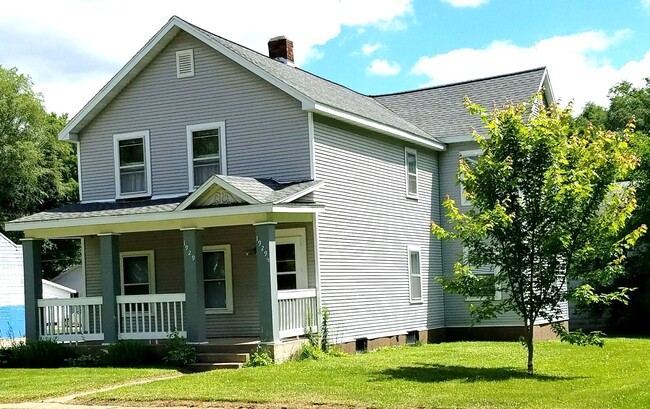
[411,30,650,112]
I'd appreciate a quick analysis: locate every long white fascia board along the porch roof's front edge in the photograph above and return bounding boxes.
[5,204,324,231]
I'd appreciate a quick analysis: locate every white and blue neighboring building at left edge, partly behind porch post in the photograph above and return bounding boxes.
[0,233,77,339]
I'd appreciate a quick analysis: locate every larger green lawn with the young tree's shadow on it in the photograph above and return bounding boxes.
[77,339,650,408]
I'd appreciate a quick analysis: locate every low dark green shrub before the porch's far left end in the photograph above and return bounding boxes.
[7,339,73,368]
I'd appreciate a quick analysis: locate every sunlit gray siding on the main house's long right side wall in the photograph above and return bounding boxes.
[314,116,444,342]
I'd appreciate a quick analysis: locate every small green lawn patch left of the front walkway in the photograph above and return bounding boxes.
[0,368,176,403]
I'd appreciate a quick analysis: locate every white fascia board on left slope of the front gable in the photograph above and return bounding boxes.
[59,17,179,141]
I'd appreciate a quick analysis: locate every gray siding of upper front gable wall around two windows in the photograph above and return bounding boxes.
[79,32,311,202]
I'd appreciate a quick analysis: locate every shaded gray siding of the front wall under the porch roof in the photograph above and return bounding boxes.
[85,224,316,337]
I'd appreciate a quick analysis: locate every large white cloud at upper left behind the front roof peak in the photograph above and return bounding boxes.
[0,0,413,114]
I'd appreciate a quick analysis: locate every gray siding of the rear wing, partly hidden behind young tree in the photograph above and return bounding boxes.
[440,142,567,327]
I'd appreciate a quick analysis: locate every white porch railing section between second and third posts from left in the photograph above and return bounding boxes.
[117,293,187,339]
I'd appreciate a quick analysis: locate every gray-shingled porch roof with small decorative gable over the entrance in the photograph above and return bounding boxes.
[5,175,322,235]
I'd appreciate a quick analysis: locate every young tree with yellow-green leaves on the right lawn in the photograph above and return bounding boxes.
[432,95,645,374]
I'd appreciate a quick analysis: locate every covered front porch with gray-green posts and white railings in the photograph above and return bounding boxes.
[6,175,322,344]
